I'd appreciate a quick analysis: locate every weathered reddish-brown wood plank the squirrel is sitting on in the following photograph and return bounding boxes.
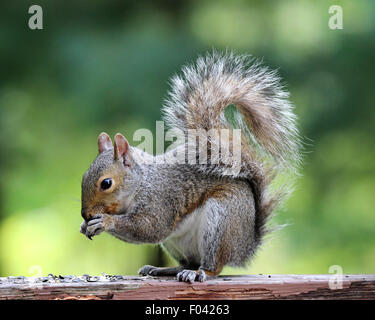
[0,275,375,300]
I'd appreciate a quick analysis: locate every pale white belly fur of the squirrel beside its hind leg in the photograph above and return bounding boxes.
[163,207,207,265]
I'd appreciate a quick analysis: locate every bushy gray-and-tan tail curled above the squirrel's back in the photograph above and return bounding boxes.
[163,52,299,239]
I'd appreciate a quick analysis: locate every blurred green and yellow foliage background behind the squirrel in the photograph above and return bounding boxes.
[0,0,375,276]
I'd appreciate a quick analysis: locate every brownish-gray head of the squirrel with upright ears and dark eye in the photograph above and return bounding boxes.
[81,132,136,221]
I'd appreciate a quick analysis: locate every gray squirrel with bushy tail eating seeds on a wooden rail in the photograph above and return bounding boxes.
[81,52,300,283]
